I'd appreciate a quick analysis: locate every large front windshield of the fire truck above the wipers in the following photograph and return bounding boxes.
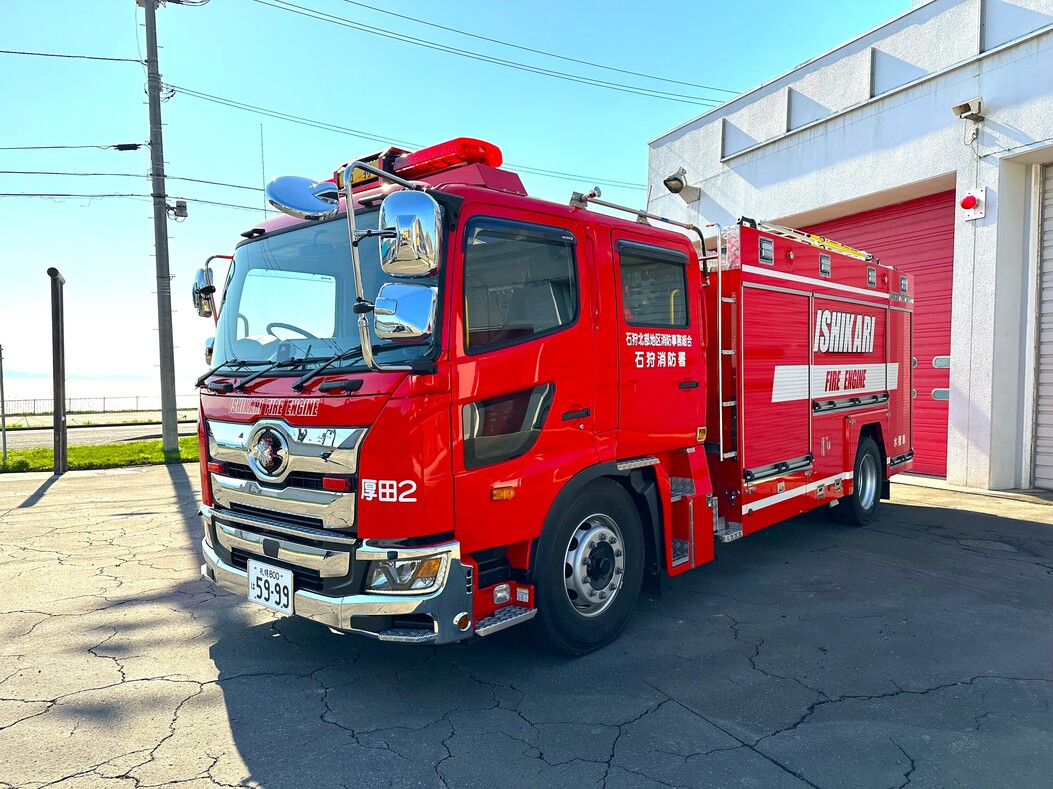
[213,211,431,375]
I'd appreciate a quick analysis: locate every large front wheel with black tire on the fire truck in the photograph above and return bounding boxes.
[534,479,643,655]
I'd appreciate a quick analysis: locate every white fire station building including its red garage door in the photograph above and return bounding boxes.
[648,0,1053,490]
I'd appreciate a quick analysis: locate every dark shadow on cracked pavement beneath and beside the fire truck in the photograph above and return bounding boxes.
[201,505,1053,787]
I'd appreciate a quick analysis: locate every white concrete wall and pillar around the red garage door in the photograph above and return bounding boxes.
[649,0,1053,489]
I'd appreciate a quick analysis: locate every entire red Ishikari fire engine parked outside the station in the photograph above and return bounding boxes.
[194,138,914,654]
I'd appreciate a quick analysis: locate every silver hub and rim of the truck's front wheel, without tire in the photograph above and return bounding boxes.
[563,514,625,616]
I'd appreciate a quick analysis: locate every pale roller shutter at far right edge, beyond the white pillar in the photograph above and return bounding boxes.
[1035,164,1053,490]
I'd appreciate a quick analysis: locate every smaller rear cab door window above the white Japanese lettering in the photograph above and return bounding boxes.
[617,241,688,329]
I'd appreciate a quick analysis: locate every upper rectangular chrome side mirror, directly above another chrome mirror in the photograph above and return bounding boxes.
[380,190,442,278]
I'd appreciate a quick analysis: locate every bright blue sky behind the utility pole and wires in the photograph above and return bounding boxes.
[0,0,911,399]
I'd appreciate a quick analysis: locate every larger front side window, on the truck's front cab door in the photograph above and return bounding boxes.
[464,217,578,353]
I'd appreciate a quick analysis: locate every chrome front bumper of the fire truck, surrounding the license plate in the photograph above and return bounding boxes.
[201,507,473,644]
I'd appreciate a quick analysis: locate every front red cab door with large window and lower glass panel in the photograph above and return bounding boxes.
[451,209,596,551]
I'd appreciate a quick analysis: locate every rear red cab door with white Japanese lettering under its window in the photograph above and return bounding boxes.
[612,231,706,458]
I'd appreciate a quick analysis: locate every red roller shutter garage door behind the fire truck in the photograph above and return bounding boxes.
[803,191,955,476]
